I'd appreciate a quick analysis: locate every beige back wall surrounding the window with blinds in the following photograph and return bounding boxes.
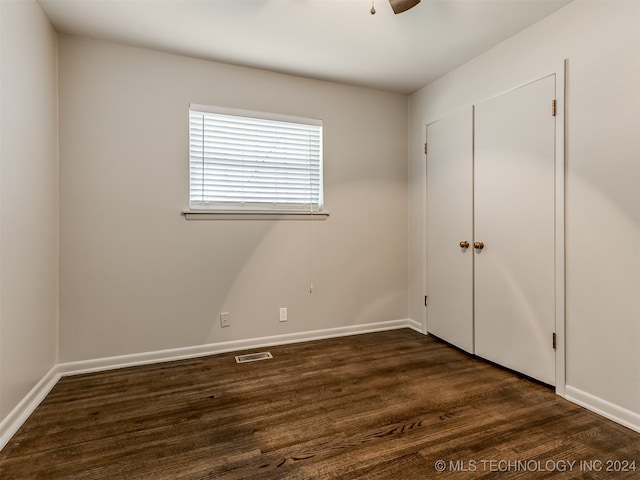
[59,36,407,361]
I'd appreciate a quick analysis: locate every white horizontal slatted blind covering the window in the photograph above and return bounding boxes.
[189,104,323,212]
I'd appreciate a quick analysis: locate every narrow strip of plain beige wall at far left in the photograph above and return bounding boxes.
[0,1,58,421]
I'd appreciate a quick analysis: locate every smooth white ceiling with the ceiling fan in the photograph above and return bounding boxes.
[40,0,571,93]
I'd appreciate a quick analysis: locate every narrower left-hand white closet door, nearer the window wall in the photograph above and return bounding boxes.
[427,107,473,353]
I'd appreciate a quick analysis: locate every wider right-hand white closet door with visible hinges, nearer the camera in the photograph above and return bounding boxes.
[473,75,555,385]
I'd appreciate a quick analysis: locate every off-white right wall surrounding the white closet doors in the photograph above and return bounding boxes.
[409,0,640,429]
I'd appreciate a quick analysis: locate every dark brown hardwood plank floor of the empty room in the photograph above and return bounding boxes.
[0,330,640,480]
